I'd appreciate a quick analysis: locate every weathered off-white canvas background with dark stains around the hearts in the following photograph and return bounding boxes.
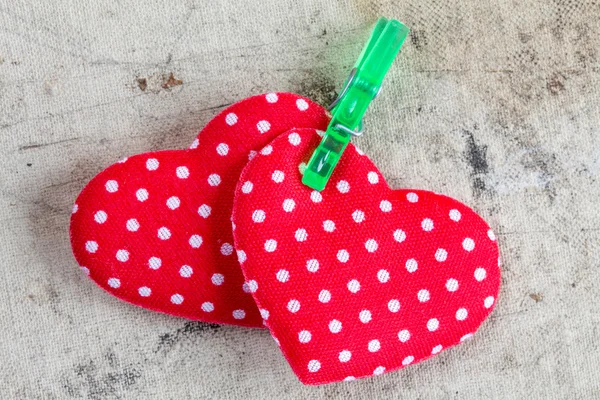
[0,0,600,400]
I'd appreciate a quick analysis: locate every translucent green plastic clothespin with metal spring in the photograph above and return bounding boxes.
[302,18,409,191]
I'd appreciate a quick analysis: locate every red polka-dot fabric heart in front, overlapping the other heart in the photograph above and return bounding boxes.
[233,129,500,384]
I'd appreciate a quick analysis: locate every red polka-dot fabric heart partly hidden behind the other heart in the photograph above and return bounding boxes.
[71,93,328,327]
